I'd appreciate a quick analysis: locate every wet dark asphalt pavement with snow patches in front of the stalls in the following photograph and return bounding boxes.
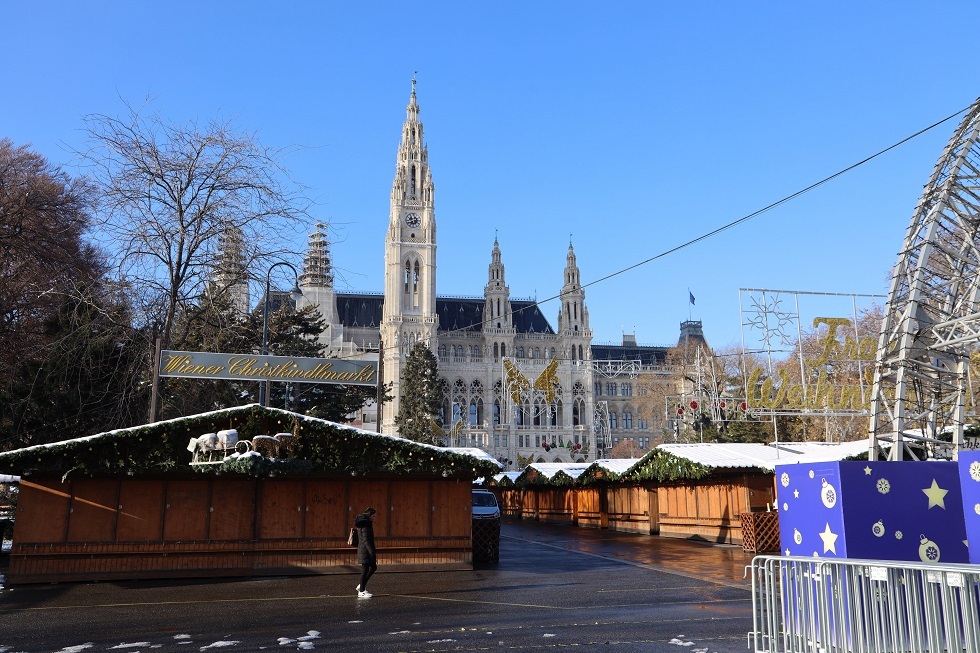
[0,520,752,653]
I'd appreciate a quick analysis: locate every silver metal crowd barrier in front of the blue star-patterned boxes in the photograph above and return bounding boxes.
[746,556,980,653]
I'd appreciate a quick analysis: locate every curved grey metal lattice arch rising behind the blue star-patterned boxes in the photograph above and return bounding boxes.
[869,100,980,460]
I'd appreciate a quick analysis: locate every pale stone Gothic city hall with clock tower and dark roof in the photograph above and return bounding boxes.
[290,80,703,469]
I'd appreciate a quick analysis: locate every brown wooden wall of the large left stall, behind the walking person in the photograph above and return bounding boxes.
[8,477,472,584]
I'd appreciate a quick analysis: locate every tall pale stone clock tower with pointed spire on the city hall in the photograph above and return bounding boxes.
[381,78,438,434]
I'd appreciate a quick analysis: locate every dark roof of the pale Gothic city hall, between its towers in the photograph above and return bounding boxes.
[337,293,555,334]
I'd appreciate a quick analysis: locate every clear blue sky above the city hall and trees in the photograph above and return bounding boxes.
[7,1,980,345]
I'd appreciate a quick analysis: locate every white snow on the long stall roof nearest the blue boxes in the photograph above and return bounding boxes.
[657,440,868,472]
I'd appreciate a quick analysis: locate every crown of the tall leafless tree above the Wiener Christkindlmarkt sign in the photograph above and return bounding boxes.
[79,106,309,346]
